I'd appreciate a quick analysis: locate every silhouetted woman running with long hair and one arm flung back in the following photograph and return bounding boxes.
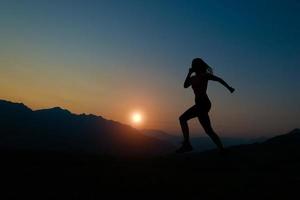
[176,58,234,153]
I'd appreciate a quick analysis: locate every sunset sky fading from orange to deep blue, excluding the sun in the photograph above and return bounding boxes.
[0,0,300,137]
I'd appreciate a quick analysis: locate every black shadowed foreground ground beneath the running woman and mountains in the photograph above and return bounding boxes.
[1,145,300,199]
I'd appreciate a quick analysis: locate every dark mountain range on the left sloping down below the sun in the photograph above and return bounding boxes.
[0,100,174,155]
